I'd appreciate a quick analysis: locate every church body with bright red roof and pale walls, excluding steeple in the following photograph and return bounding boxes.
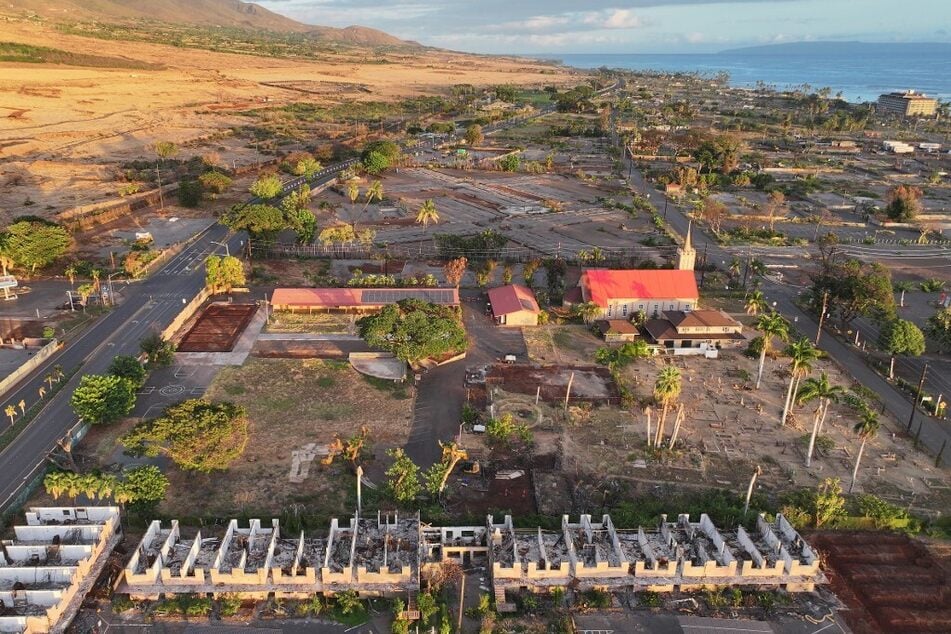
[578,269,700,319]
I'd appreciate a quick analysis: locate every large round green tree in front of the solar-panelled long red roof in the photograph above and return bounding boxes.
[357,299,466,363]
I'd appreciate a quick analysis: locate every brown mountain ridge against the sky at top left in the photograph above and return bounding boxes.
[0,0,419,47]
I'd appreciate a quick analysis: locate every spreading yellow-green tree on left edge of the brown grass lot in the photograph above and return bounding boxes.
[120,399,249,473]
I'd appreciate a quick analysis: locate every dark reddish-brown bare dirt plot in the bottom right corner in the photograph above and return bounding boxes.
[810,533,951,634]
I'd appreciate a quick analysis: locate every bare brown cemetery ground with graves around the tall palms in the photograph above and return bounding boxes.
[512,320,951,514]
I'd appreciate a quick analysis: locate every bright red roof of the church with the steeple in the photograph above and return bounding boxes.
[581,269,700,308]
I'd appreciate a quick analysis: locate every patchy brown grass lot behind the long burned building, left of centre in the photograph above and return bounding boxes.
[143,358,412,517]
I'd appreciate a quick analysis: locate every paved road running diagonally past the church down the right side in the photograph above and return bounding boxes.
[612,132,951,465]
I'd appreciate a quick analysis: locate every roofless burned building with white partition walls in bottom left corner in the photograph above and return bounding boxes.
[0,506,121,634]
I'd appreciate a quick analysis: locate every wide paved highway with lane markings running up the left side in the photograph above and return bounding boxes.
[0,161,352,511]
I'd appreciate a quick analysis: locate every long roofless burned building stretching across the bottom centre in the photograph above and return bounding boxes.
[119,512,825,610]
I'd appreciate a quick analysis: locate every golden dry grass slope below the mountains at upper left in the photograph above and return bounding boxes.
[0,19,577,224]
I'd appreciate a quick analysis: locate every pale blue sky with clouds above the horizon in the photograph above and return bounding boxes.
[257,0,951,54]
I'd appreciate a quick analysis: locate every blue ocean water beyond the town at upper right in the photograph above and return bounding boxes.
[539,45,951,102]
